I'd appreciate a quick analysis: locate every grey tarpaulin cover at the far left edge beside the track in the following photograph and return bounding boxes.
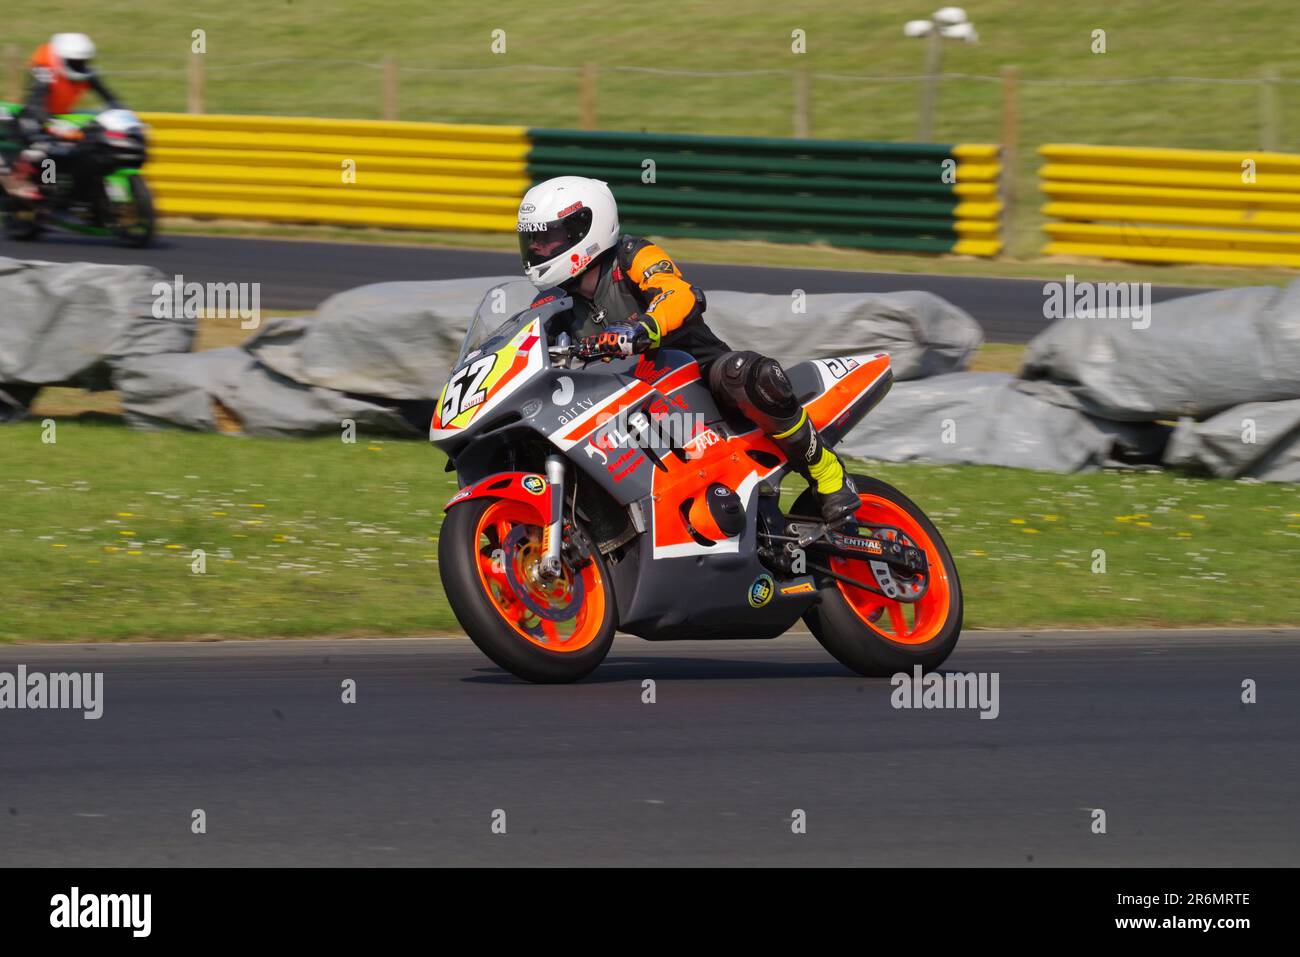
[0,257,194,416]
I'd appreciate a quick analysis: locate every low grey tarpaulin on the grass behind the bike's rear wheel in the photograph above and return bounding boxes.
[841,372,1161,472]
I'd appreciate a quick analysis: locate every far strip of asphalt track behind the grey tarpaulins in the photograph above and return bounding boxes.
[0,235,1206,342]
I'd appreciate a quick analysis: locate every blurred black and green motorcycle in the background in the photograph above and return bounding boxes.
[0,104,156,247]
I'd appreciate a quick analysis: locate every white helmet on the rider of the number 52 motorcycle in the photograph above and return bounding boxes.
[516,176,619,289]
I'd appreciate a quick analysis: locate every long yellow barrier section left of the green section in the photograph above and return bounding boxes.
[142,113,529,231]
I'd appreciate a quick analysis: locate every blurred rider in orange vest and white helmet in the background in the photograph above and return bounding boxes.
[4,34,122,202]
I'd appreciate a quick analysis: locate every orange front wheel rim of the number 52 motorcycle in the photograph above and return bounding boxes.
[475,499,605,651]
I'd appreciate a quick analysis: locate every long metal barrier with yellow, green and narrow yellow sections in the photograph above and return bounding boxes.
[142,113,1002,256]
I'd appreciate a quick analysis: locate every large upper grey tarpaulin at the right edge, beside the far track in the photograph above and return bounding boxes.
[1021,281,1300,421]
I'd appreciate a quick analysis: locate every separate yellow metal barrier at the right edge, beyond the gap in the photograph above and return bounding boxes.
[1039,143,1300,267]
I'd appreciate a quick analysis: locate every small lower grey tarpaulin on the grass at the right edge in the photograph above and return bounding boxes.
[1165,399,1300,482]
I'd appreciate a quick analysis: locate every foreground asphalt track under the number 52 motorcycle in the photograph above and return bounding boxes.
[0,629,1300,866]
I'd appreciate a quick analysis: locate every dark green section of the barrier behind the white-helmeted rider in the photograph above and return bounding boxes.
[528,129,977,252]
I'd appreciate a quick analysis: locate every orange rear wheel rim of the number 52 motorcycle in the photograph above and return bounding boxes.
[831,493,952,645]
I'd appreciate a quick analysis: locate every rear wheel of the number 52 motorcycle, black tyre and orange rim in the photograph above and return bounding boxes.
[790,476,962,677]
